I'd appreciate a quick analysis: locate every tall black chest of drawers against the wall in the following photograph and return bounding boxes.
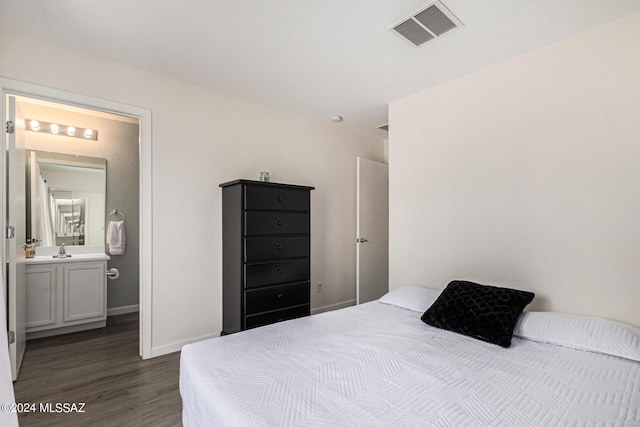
[220,179,314,335]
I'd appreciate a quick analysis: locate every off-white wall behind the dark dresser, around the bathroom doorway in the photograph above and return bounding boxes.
[0,31,383,354]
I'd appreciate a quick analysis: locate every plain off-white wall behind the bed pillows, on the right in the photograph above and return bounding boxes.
[389,15,640,325]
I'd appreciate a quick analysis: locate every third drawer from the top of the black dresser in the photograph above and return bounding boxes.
[244,237,309,261]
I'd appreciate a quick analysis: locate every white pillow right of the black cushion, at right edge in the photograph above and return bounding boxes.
[513,311,640,362]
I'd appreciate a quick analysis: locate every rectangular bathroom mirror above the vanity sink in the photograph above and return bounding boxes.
[26,150,107,247]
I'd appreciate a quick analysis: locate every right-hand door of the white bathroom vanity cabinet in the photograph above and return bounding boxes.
[62,262,107,322]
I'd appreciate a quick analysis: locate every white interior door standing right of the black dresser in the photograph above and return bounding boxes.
[356,157,389,304]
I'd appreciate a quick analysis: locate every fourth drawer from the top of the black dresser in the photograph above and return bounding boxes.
[244,258,309,288]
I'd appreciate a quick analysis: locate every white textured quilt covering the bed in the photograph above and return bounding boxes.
[180,301,640,426]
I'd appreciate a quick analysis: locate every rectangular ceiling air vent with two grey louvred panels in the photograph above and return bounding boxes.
[390,1,463,47]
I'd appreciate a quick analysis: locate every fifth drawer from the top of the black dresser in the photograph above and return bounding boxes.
[245,282,309,315]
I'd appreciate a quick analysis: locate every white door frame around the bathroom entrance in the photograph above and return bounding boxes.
[0,79,151,380]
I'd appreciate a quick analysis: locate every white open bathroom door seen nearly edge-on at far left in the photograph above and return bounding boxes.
[5,96,27,381]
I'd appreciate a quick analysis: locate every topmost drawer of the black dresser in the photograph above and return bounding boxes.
[244,185,310,211]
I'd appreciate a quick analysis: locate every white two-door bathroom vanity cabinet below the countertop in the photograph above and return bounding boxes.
[25,258,107,339]
